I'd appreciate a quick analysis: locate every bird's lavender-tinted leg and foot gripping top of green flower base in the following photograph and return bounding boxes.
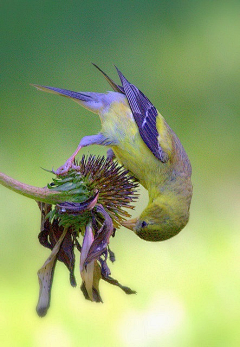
[53,133,111,175]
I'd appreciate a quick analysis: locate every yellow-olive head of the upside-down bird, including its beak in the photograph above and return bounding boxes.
[122,197,189,241]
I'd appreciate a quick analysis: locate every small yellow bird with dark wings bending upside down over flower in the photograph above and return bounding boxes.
[33,64,193,241]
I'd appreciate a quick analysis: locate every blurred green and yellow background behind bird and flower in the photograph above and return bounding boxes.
[0,0,240,347]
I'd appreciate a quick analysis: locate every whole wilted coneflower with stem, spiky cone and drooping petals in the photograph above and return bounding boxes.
[0,155,138,316]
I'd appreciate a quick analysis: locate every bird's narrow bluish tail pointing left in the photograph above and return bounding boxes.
[31,84,103,113]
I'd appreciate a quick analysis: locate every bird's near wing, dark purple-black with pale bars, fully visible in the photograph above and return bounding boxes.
[116,68,169,163]
